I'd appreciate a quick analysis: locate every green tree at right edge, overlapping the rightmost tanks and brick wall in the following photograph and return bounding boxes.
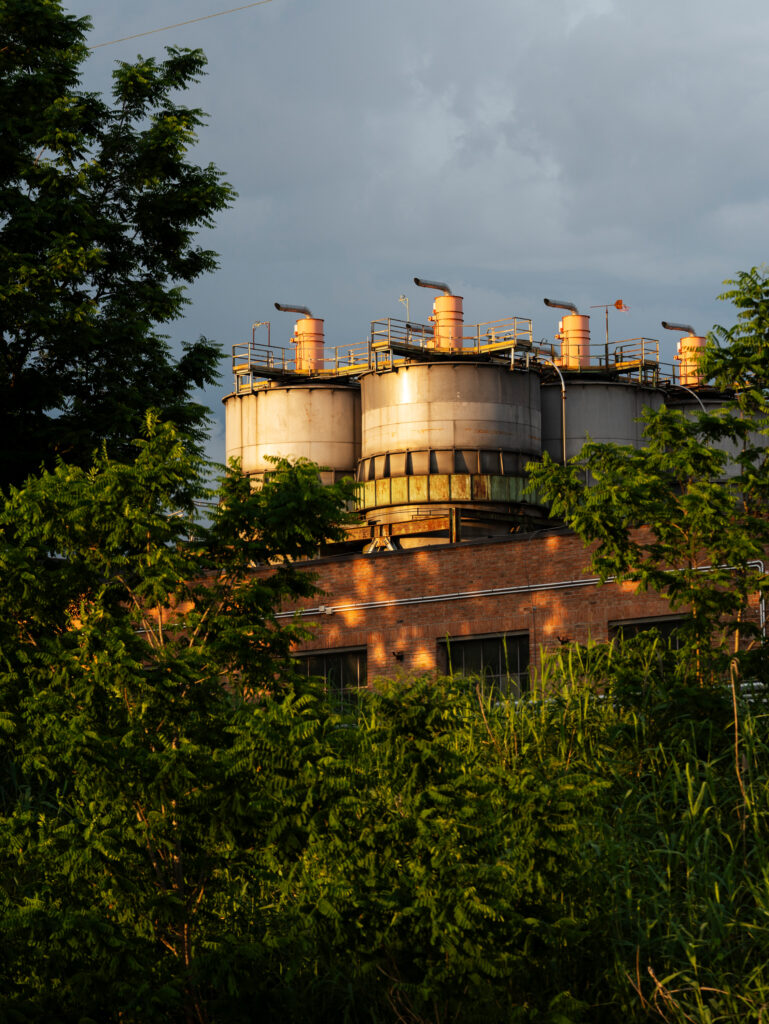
[529,269,769,683]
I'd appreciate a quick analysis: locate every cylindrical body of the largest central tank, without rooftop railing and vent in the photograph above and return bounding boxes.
[357,360,542,523]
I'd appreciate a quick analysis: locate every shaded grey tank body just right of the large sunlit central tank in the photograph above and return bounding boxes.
[542,379,664,462]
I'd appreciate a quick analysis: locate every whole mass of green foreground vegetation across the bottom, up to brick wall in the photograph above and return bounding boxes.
[0,418,769,1024]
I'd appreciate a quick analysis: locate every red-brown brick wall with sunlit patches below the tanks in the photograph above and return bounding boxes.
[278,531,758,681]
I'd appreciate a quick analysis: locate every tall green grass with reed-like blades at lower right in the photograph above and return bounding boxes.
[498,640,769,1022]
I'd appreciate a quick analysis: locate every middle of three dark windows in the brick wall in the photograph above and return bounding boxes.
[438,633,528,697]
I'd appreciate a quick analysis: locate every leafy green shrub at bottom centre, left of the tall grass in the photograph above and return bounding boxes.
[268,680,600,1021]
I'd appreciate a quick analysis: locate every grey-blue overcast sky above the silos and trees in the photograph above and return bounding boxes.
[76,0,769,460]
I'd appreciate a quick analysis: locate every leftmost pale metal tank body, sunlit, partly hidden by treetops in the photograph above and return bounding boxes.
[224,383,360,483]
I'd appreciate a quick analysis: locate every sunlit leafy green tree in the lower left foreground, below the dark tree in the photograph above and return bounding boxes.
[0,419,348,1022]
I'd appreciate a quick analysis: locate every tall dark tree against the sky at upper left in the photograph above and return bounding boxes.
[0,0,233,486]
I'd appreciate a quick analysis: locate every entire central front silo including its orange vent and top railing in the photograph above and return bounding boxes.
[357,279,542,545]
